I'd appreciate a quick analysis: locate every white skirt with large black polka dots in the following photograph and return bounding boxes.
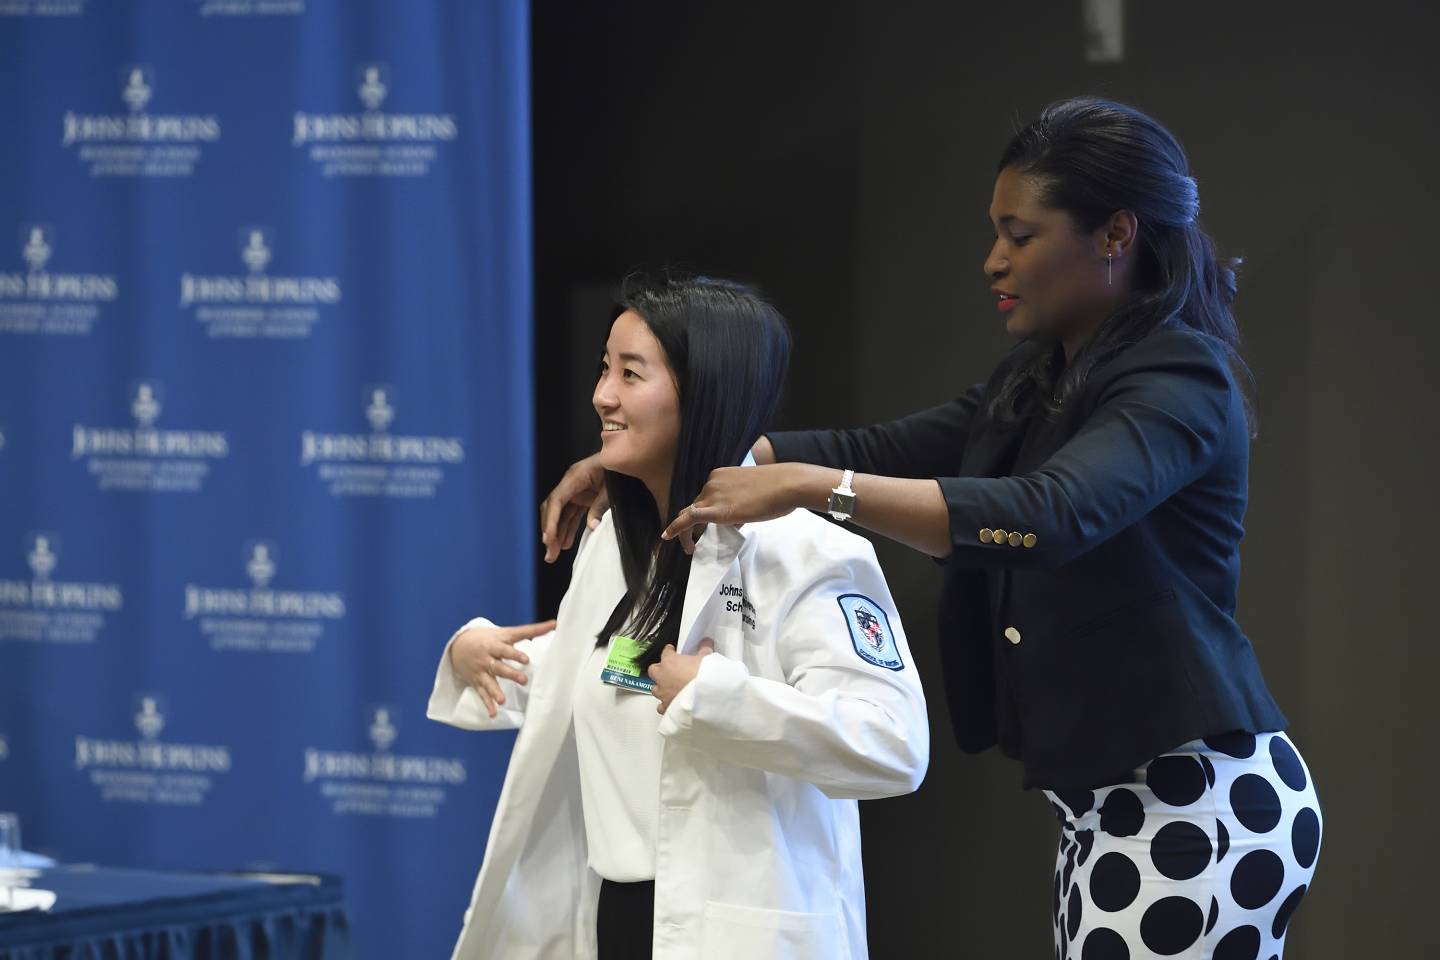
[1044,733,1322,960]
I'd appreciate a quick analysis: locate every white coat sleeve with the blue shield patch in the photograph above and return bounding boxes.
[660,534,930,800]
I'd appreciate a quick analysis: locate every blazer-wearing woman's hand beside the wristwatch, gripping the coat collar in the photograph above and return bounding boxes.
[660,463,841,553]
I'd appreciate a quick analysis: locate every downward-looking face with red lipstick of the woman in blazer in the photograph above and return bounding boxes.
[985,168,1122,340]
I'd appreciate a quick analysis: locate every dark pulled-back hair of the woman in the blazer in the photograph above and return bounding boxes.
[991,96,1256,436]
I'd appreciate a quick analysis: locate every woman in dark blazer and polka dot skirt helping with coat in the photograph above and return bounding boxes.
[543,98,1320,960]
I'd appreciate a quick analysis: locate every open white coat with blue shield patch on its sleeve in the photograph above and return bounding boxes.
[426,510,930,960]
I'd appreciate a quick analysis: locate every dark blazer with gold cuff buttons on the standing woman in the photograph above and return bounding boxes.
[769,322,1286,790]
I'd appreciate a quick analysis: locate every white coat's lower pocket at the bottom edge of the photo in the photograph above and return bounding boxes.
[700,900,850,960]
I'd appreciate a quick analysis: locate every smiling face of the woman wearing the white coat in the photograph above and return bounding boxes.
[590,309,680,489]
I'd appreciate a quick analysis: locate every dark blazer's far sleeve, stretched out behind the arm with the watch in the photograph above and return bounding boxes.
[766,383,985,478]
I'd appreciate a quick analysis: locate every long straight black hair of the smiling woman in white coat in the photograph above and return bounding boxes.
[596,276,791,665]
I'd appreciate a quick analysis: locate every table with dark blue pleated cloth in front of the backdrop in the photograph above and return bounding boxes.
[0,866,350,960]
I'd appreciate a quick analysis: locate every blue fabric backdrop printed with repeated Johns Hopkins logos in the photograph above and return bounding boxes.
[0,0,537,957]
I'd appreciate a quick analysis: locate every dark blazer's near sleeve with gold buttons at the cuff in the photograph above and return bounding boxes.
[936,334,1237,569]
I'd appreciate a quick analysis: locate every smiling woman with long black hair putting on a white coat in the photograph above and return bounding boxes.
[428,273,929,960]
